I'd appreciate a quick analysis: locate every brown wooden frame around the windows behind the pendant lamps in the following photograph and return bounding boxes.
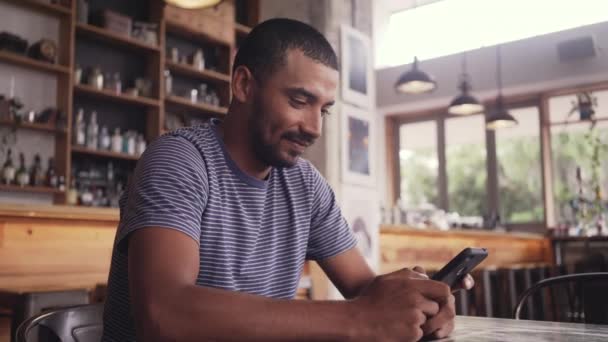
[385,81,608,233]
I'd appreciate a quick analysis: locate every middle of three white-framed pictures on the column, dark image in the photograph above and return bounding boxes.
[341,105,376,187]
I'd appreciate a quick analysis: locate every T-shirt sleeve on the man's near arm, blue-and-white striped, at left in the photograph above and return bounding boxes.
[116,135,208,245]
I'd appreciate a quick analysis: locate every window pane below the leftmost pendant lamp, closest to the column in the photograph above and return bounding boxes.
[399,121,439,207]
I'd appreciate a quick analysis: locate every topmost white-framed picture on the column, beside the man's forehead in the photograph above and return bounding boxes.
[340,25,375,109]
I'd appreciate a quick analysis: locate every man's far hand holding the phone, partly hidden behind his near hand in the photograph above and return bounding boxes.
[414,266,475,339]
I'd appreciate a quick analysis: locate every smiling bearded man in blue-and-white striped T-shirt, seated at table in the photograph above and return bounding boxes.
[104,19,472,342]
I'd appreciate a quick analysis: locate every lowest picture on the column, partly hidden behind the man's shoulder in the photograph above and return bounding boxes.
[341,185,380,271]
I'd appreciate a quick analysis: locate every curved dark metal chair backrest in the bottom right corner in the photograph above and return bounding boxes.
[513,272,608,324]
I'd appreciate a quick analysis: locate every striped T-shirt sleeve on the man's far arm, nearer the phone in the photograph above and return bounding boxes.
[306,167,357,260]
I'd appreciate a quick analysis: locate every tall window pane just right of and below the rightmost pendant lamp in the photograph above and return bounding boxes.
[495,107,544,223]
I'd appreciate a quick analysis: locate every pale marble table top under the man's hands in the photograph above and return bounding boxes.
[436,316,608,342]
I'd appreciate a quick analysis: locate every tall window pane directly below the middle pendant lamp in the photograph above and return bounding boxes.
[445,115,487,216]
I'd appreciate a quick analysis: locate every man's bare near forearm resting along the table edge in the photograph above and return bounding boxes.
[137,286,355,342]
